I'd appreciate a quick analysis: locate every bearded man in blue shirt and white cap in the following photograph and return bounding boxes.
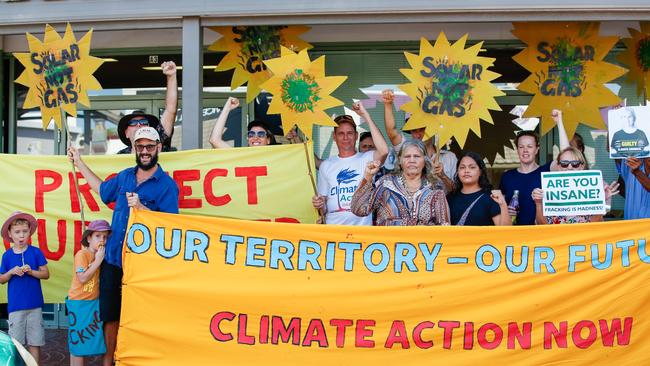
[68,127,178,365]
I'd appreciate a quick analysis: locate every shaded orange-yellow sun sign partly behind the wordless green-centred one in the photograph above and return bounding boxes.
[208,25,312,103]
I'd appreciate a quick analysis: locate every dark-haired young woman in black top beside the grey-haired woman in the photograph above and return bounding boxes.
[447,151,512,226]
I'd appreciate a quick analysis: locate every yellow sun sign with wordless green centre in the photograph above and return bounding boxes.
[262,47,347,139]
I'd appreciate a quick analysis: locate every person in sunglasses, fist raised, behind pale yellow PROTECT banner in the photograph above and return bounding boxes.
[210,97,277,149]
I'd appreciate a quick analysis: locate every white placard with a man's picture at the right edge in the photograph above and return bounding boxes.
[607,107,650,159]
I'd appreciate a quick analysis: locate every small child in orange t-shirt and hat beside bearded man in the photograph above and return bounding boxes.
[68,220,111,366]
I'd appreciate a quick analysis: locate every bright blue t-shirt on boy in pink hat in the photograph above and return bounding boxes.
[0,245,47,313]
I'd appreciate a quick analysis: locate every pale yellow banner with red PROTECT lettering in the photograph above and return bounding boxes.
[0,144,316,302]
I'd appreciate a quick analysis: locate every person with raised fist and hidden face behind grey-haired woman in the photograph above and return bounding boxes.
[382,89,458,192]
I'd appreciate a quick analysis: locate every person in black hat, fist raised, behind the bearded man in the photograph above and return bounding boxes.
[117,61,178,154]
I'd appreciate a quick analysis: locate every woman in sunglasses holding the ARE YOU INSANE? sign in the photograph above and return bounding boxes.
[532,146,618,225]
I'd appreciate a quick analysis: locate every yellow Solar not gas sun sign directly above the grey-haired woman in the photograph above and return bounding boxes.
[399,32,504,147]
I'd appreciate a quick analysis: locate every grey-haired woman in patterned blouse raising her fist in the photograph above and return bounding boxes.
[352,140,449,226]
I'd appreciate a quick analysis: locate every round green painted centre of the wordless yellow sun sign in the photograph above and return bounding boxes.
[281,69,321,113]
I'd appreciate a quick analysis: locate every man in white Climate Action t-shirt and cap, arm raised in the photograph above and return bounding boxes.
[312,103,388,225]
